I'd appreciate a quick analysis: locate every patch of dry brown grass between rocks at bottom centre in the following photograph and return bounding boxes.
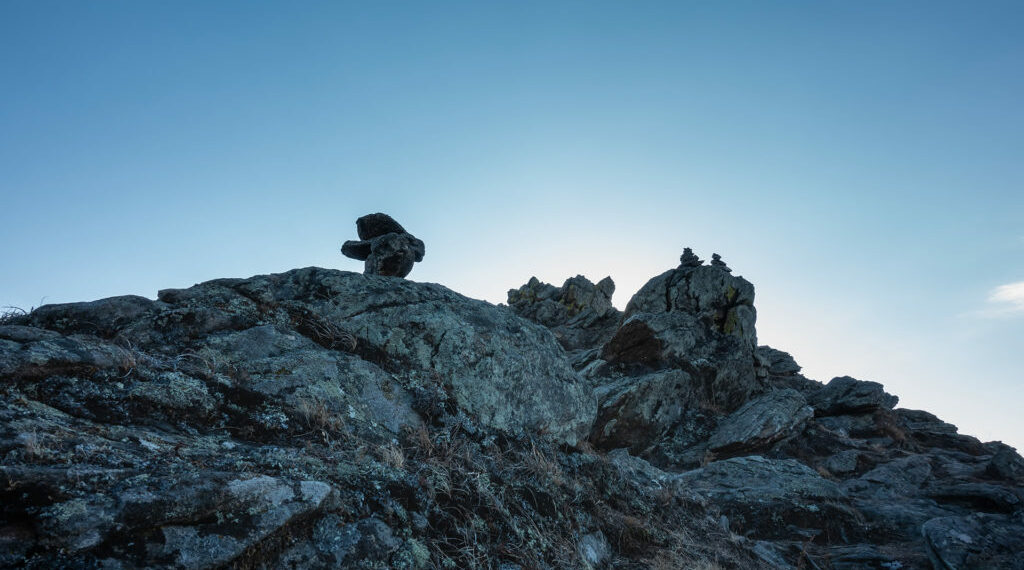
[381,424,770,570]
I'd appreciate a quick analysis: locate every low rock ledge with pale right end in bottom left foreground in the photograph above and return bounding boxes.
[0,464,334,568]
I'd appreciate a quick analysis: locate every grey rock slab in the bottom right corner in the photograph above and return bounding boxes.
[922,515,1024,570]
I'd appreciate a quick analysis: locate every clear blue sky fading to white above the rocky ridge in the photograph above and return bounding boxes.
[0,0,1024,449]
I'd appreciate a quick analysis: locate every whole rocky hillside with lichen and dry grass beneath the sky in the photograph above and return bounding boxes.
[0,252,1024,570]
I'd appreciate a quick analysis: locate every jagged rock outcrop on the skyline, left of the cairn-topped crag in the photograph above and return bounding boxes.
[508,275,622,350]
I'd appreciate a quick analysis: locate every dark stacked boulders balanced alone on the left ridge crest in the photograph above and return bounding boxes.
[341,213,426,277]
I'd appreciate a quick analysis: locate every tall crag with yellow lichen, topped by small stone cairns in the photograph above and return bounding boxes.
[583,250,765,469]
